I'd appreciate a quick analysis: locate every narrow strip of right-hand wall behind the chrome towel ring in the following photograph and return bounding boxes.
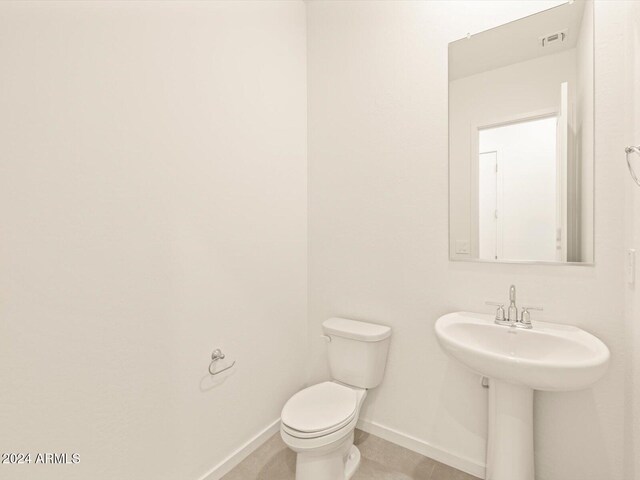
[620,2,640,480]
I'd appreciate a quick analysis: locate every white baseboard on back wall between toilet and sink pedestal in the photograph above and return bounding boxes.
[357,418,485,478]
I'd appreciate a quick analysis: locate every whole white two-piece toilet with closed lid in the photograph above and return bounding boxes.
[280,318,391,480]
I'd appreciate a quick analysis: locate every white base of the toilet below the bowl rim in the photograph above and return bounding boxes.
[296,432,360,480]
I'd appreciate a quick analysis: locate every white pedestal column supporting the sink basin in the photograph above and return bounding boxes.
[486,378,534,480]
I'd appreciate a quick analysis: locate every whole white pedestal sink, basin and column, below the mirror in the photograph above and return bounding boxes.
[435,312,609,480]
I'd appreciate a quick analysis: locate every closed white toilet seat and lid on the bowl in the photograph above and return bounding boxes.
[281,382,359,438]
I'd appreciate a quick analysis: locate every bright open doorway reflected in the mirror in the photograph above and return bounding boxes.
[478,115,563,262]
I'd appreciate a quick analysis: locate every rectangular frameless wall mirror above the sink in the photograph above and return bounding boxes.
[449,0,594,264]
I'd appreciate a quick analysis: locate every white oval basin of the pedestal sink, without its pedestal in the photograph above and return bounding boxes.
[436,312,609,391]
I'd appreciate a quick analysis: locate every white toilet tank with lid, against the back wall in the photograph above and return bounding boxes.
[322,317,391,388]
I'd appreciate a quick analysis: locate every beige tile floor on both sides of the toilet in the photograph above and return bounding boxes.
[222,430,478,480]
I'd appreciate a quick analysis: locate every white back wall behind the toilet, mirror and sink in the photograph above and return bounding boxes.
[307,1,627,480]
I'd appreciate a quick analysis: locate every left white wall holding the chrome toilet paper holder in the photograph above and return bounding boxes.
[0,1,307,480]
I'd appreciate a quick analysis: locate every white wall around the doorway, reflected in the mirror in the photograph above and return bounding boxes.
[449,48,576,261]
